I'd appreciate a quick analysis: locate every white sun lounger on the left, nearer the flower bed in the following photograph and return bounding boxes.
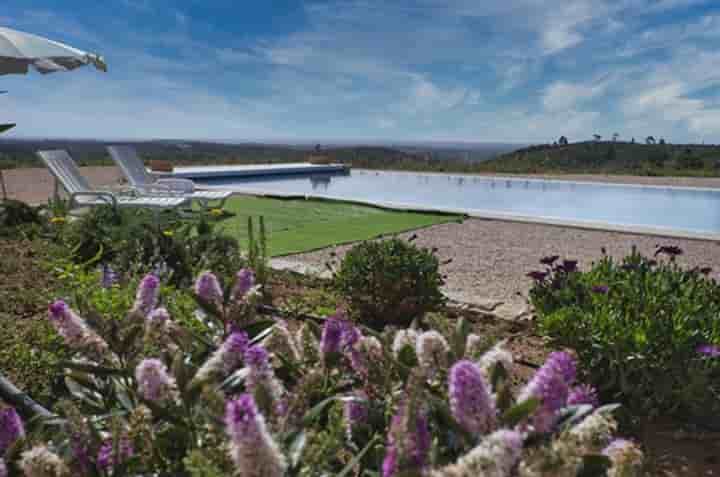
[37,150,190,211]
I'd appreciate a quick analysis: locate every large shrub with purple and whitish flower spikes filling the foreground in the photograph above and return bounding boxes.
[0,270,642,477]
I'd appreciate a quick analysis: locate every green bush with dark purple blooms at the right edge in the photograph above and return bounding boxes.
[529,246,720,415]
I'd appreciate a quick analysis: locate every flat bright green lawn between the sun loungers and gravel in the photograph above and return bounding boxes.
[218,196,462,256]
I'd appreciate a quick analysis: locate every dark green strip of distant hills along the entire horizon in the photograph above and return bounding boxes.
[0,138,720,176]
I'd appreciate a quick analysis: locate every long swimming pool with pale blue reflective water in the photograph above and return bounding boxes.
[204,170,720,239]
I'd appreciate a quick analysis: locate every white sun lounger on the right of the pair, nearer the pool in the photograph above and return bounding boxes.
[107,146,232,208]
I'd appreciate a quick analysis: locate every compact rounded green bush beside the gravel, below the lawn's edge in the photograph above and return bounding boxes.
[335,239,445,328]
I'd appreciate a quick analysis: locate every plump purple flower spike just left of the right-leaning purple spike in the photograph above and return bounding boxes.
[449,360,497,434]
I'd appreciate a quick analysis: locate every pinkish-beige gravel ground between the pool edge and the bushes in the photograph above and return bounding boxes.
[286,219,720,304]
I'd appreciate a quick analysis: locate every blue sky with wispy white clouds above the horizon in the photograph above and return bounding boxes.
[0,0,720,143]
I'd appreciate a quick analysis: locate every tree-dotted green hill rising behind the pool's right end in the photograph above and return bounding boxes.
[478,141,720,176]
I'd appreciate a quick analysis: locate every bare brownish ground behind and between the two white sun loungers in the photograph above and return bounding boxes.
[0,167,123,204]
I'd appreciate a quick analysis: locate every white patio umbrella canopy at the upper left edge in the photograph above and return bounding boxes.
[0,27,107,75]
